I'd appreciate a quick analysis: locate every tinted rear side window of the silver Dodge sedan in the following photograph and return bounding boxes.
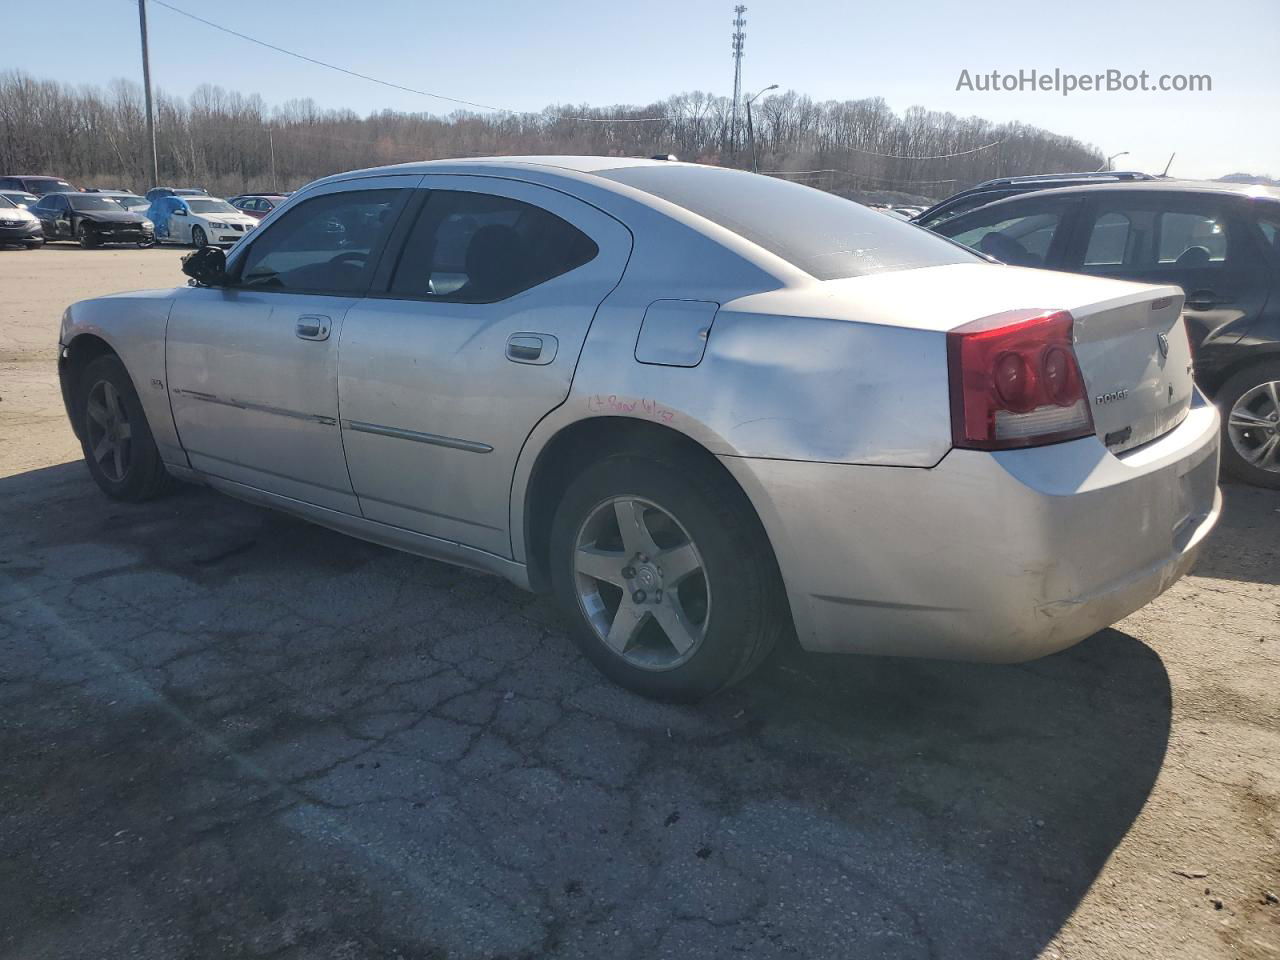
[390,189,599,303]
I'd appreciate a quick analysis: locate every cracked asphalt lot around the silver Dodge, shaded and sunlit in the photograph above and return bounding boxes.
[0,250,1280,960]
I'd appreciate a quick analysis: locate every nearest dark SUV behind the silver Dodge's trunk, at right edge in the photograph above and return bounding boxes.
[934,179,1280,489]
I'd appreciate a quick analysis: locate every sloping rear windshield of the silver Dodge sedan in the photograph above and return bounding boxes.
[599,165,978,280]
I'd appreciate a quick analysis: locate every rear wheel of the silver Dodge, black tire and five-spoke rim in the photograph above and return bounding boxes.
[549,453,788,703]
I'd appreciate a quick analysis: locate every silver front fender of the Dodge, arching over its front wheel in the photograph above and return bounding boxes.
[58,291,188,467]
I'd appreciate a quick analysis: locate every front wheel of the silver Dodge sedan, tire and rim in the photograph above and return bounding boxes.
[76,353,169,503]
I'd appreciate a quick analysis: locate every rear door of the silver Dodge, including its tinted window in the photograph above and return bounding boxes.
[338,175,631,557]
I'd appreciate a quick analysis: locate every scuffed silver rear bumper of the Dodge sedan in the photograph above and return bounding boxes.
[722,397,1221,662]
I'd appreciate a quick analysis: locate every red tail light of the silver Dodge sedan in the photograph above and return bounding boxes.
[947,310,1093,451]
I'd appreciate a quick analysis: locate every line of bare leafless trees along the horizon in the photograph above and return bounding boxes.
[0,72,1103,197]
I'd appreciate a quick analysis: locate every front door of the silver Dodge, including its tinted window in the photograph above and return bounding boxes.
[168,177,420,513]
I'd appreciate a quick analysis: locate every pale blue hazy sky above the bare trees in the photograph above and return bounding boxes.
[0,0,1280,178]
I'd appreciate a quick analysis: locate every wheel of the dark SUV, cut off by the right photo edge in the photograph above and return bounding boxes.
[1215,360,1280,490]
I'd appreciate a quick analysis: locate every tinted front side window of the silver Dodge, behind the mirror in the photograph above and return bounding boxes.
[237,189,401,293]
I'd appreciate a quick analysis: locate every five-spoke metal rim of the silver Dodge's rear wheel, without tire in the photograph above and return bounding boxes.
[573,497,712,671]
